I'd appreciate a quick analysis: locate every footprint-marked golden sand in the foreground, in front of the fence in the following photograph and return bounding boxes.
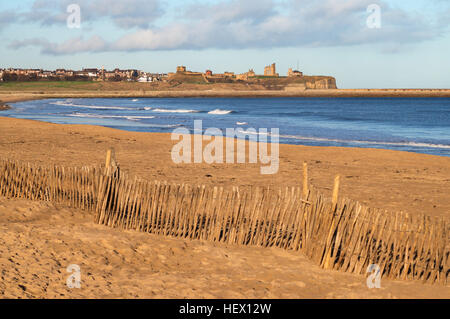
[0,199,450,299]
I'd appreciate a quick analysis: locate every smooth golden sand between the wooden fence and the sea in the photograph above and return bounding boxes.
[0,114,450,217]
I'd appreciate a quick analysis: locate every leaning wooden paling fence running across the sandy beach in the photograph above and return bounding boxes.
[0,156,450,285]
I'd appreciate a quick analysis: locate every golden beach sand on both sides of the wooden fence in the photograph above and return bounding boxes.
[0,114,450,298]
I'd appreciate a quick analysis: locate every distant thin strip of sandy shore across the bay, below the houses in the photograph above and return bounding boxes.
[0,81,450,102]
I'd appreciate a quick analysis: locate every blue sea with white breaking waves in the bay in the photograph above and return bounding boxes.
[4,98,450,156]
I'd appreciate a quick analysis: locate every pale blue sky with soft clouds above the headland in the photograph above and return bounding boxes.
[0,0,450,88]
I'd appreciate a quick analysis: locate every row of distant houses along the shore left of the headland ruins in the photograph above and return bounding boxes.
[0,68,167,82]
